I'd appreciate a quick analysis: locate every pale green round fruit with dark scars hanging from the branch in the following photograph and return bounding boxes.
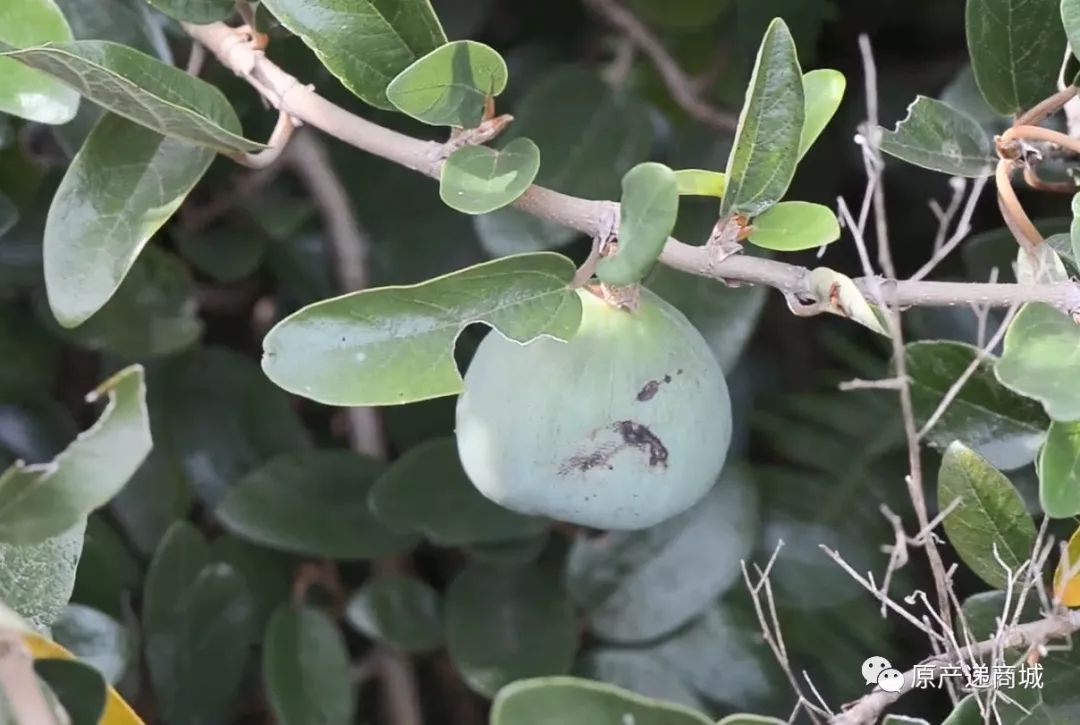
[457,288,731,529]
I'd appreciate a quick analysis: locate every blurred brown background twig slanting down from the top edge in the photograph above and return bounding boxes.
[585,0,739,131]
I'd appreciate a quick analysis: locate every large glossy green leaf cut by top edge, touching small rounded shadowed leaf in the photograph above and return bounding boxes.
[262,0,446,110]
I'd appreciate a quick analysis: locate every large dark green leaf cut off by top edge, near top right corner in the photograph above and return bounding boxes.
[967,0,1066,116]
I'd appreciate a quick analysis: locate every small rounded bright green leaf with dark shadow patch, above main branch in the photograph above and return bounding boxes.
[387,40,508,129]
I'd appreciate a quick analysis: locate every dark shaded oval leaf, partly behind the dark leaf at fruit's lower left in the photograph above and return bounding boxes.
[216,451,416,560]
